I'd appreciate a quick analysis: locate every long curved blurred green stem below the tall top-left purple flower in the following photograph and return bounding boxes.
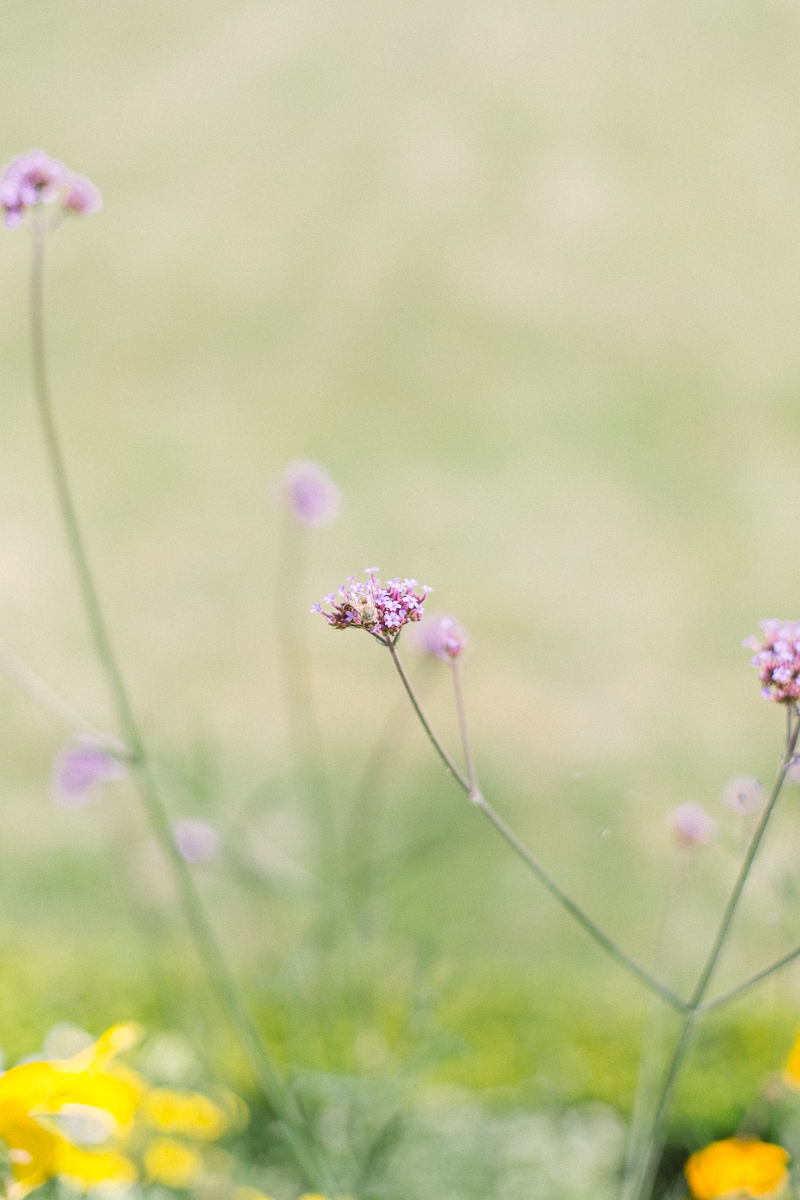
[30,220,319,1184]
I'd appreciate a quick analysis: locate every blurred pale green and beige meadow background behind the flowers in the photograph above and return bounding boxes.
[0,0,800,1196]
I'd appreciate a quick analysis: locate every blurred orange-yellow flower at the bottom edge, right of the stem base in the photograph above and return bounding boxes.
[685,1138,789,1200]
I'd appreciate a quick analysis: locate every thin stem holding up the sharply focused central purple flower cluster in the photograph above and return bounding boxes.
[386,642,686,1013]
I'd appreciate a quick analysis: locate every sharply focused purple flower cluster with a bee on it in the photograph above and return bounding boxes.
[311,566,432,640]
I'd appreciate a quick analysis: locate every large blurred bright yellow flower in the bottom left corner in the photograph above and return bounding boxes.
[0,1022,144,1200]
